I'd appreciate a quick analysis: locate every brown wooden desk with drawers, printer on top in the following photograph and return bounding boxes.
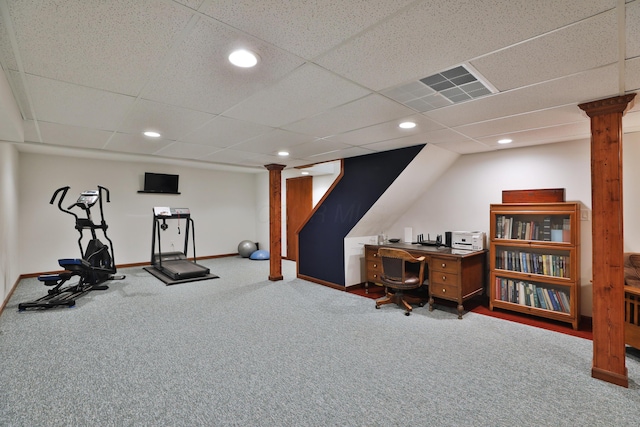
[365,243,486,319]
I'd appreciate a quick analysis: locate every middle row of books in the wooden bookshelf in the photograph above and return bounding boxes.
[496,249,571,278]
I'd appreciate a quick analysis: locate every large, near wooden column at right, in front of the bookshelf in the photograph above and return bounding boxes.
[578,94,635,387]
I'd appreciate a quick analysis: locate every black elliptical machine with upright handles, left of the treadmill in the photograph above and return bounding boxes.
[18,186,125,311]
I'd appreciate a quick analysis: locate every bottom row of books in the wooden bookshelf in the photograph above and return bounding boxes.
[495,277,571,313]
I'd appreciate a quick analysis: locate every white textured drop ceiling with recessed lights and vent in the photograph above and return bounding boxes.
[0,0,640,171]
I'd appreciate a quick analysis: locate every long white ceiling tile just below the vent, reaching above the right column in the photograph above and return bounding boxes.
[424,65,618,127]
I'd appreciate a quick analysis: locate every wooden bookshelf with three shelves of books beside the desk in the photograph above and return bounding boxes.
[489,202,580,330]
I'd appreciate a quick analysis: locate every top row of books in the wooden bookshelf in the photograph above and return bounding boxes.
[496,215,571,242]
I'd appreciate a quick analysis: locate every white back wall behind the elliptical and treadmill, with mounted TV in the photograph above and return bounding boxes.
[18,153,258,274]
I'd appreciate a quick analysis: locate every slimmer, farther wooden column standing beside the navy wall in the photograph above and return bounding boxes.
[264,164,284,282]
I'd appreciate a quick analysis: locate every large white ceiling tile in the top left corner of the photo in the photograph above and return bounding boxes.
[9,0,191,95]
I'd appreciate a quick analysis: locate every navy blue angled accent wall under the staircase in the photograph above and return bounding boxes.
[298,145,424,286]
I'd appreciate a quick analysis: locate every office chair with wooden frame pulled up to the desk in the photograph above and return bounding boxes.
[376,248,426,316]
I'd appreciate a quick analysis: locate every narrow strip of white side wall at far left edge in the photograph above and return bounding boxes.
[0,142,20,305]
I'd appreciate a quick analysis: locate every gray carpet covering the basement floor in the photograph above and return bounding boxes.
[0,257,640,426]
